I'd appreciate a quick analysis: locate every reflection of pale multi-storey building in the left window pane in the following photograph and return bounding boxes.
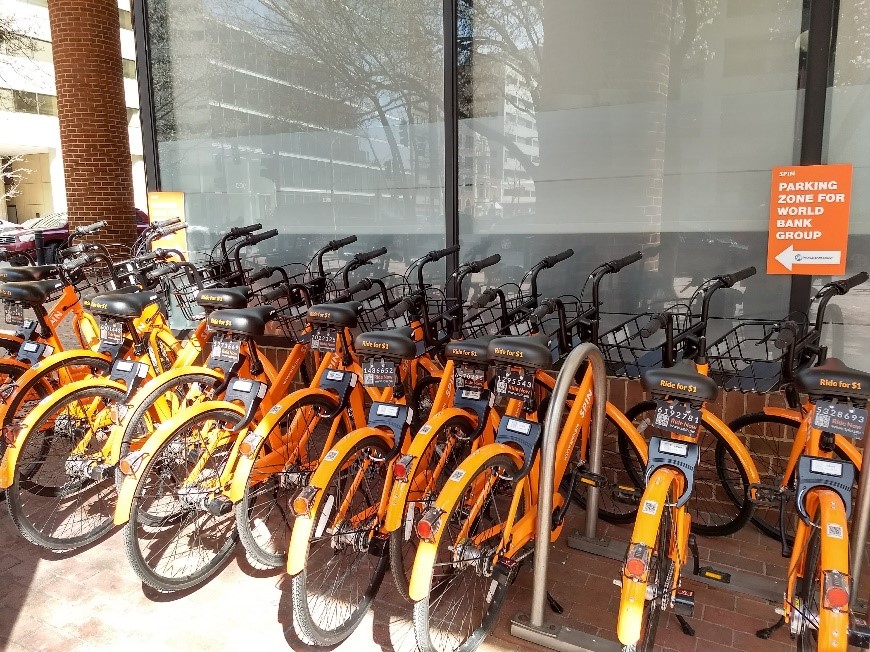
[149,0,443,238]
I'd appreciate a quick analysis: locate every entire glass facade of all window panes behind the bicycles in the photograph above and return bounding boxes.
[145,0,870,356]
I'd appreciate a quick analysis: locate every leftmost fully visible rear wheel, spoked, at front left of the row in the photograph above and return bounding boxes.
[6,385,124,550]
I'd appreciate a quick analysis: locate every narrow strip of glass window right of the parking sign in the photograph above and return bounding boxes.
[813,0,870,371]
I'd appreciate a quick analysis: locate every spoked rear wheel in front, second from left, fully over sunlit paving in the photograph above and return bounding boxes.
[124,407,241,593]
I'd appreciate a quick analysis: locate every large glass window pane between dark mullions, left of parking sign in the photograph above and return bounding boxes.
[458,0,808,324]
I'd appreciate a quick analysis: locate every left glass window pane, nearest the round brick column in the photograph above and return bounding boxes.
[147,0,445,298]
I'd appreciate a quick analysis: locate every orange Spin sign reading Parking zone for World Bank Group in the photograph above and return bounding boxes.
[767,163,852,276]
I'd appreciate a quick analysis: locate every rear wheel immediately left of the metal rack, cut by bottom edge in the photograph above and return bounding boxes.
[413,454,523,652]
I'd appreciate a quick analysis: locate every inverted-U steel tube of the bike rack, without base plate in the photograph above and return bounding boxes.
[529,344,608,628]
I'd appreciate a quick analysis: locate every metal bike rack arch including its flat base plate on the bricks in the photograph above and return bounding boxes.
[511,344,622,652]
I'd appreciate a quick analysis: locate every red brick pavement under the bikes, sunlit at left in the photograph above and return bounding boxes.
[0,488,832,652]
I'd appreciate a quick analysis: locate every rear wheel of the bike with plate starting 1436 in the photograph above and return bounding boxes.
[291,436,390,645]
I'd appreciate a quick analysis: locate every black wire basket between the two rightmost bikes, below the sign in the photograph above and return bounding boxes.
[707,319,804,394]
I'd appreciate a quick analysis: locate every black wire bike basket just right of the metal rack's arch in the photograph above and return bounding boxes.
[598,304,692,379]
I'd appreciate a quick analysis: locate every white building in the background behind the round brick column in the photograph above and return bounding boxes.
[0,0,147,222]
